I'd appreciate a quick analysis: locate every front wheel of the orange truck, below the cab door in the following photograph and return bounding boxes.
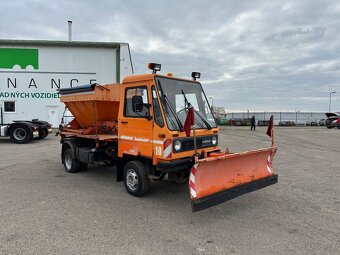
[123,161,150,197]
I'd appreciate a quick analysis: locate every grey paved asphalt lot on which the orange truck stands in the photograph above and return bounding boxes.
[0,127,340,255]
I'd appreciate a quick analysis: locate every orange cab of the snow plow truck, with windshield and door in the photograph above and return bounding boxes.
[118,66,218,172]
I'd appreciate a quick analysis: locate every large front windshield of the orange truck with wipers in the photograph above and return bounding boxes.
[155,77,216,131]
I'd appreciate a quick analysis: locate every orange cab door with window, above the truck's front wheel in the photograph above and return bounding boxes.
[118,84,153,158]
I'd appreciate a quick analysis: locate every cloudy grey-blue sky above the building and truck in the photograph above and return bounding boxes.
[0,0,340,112]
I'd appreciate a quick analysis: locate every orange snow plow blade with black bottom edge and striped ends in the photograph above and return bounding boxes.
[189,147,278,212]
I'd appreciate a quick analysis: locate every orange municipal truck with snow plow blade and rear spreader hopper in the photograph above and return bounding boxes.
[59,63,278,212]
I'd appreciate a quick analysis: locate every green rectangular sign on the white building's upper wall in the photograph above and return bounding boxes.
[0,48,39,69]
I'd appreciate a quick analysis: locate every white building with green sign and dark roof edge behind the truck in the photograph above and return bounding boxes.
[0,40,133,127]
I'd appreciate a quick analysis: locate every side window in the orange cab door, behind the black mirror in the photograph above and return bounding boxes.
[124,87,150,117]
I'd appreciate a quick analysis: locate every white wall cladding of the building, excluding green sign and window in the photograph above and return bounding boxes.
[0,42,132,126]
